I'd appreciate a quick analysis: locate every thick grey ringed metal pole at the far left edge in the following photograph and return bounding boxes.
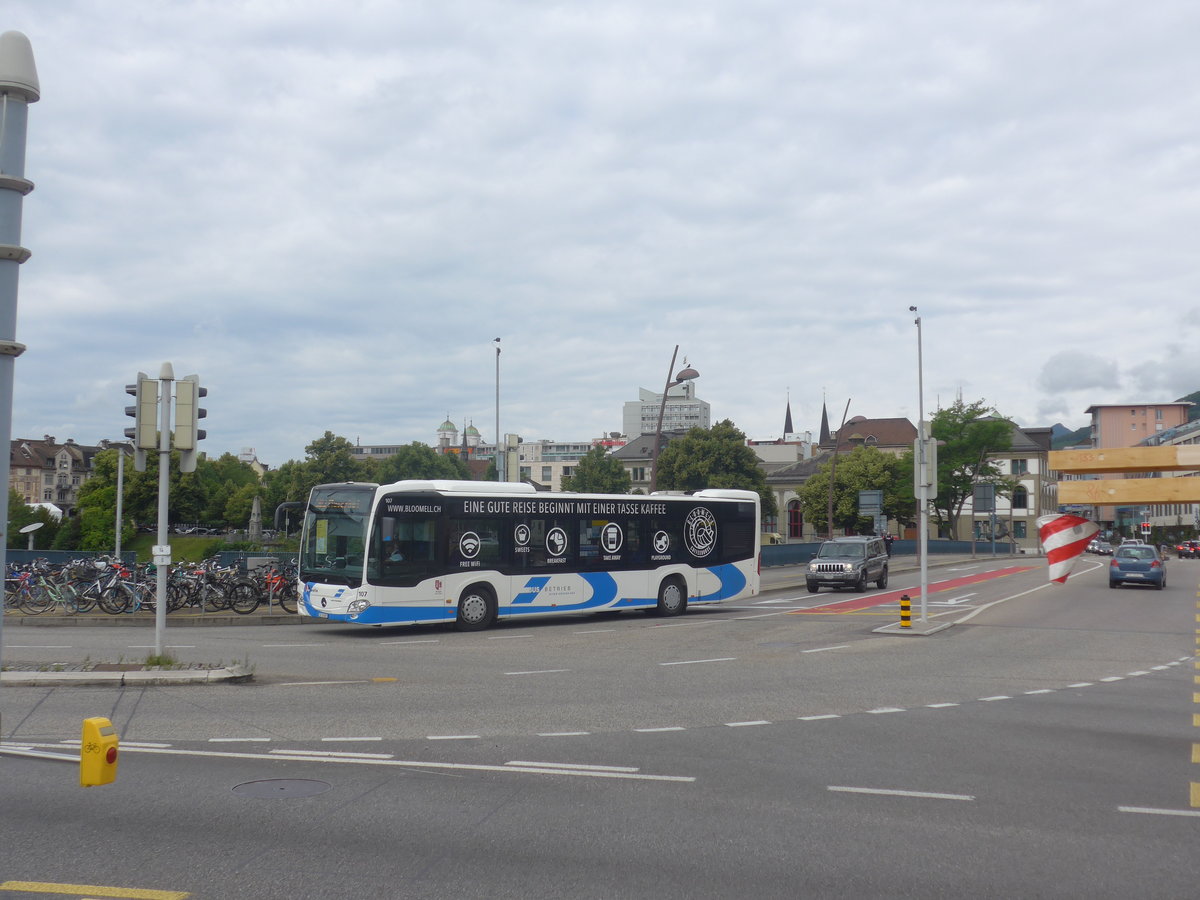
[0,31,42,668]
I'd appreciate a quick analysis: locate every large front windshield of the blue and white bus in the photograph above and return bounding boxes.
[300,484,376,587]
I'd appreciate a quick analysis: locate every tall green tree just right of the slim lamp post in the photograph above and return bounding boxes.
[926,400,1013,534]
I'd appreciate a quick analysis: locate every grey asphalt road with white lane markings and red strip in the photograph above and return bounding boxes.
[0,559,1200,900]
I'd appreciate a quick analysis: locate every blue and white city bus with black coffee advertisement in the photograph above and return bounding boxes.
[299,481,760,630]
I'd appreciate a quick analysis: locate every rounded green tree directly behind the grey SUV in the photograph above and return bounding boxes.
[796,446,913,534]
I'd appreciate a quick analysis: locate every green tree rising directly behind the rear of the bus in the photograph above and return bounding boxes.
[658,419,776,517]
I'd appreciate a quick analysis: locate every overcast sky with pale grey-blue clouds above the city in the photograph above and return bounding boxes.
[0,0,1200,466]
